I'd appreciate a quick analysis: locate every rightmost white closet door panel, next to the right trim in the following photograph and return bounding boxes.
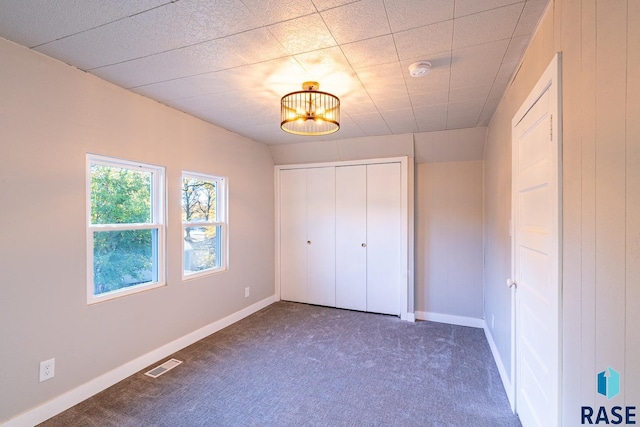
[367,163,402,315]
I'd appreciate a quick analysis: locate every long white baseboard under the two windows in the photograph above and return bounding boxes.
[2,296,276,427]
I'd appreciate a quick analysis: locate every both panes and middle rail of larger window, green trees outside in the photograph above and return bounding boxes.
[89,156,161,296]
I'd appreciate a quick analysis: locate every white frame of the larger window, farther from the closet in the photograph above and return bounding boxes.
[86,153,166,304]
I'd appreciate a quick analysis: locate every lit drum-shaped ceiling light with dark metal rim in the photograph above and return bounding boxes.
[280,82,340,136]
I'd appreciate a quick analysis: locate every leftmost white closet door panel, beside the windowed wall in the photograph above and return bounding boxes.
[280,169,307,302]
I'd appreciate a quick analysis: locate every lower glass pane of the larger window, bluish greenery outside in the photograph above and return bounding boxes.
[93,229,158,295]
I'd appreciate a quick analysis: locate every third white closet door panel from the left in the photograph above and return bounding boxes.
[336,165,367,311]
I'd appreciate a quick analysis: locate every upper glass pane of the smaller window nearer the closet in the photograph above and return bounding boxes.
[182,177,218,222]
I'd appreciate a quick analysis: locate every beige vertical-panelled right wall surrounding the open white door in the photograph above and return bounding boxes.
[485,0,640,426]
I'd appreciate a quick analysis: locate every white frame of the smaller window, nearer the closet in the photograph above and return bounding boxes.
[180,171,229,281]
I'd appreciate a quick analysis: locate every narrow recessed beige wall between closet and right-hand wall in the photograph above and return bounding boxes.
[415,160,483,319]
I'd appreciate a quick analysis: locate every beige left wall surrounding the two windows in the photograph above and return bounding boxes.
[0,39,274,423]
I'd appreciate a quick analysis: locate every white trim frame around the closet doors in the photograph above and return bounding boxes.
[274,157,415,322]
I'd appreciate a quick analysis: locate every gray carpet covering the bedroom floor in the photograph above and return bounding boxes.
[41,302,520,427]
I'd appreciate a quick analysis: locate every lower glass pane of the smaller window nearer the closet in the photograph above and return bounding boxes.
[184,225,222,274]
